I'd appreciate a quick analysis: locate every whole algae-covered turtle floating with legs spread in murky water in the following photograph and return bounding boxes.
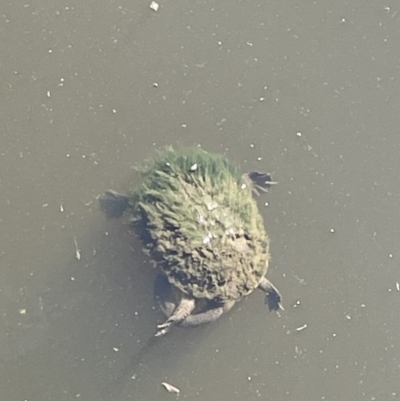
[98,147,283,336]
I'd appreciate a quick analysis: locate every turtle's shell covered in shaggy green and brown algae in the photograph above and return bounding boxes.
[130,148,269,302]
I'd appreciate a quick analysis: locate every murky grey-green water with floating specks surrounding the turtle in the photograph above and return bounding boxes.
[0,0,400,401]
